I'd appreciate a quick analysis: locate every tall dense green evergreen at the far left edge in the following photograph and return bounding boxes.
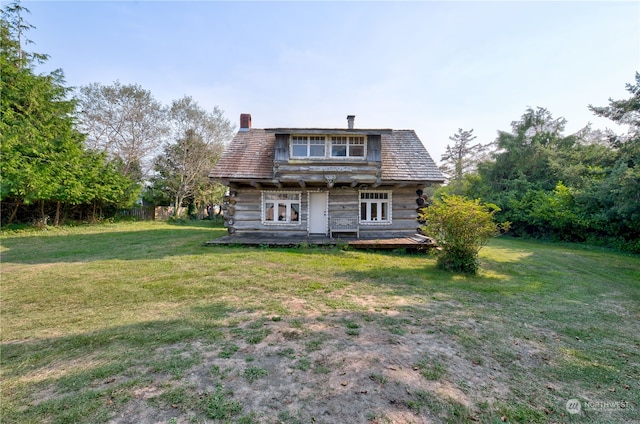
[0,3,136,224]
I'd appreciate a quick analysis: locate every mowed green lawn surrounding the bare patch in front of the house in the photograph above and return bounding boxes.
[0,222,640,423]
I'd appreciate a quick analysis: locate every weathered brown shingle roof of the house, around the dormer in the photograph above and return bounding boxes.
[209,124,445,183]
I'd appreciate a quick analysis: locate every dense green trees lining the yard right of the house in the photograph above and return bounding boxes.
[437,73,640,253]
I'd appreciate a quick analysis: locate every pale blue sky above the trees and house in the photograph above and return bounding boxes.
[21,0,640,161]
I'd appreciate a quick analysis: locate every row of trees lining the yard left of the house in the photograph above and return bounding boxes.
[0,2,234,225]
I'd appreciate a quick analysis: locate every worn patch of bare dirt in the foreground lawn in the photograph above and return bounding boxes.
[112,311,508,424]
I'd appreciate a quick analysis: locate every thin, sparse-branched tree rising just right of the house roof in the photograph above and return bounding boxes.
[440,128,488,190]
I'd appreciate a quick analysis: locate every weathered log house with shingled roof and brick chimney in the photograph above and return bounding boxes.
[209,114,445,239]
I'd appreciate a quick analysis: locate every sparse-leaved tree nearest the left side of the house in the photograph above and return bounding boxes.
[150,97,233,215]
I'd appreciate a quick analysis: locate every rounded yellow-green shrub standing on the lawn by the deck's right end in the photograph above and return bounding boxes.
[418,195,509,273]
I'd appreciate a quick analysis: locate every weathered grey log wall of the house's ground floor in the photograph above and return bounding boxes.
[225,186,418,238]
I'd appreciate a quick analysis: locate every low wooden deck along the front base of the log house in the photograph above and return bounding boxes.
[206,234,437,251]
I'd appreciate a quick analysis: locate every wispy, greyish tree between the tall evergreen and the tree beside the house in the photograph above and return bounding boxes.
[78,81,169,181]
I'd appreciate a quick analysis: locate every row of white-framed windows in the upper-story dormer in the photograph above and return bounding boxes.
[291,135,366,159]
